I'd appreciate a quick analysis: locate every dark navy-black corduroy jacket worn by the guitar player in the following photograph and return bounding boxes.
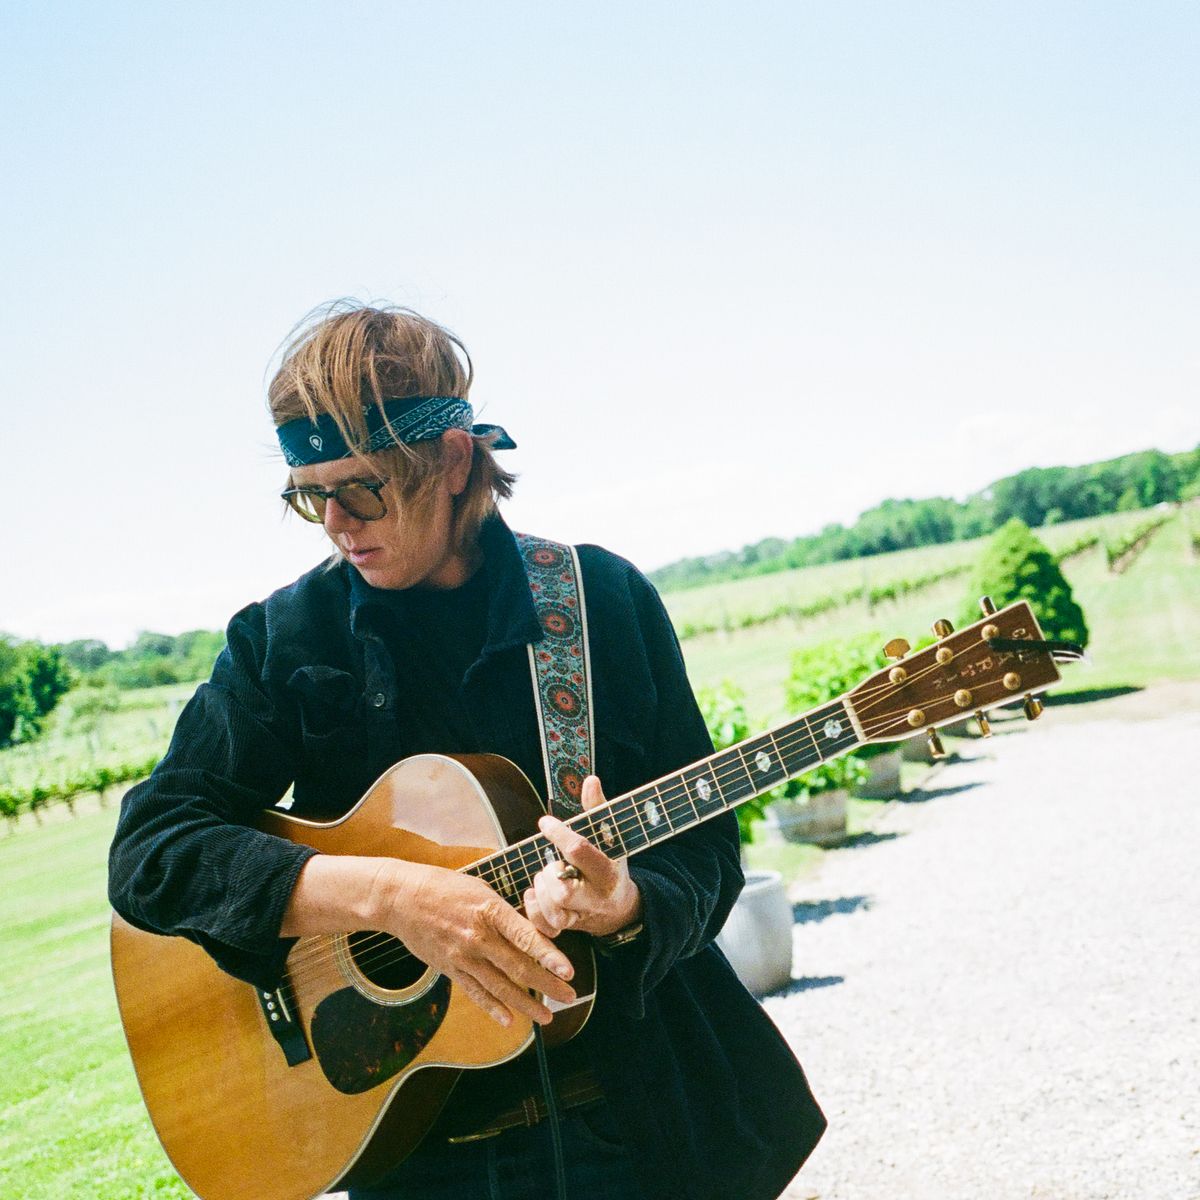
[109,518,824,1200]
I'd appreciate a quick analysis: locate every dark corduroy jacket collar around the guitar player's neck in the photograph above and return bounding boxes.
[340,514,545,658]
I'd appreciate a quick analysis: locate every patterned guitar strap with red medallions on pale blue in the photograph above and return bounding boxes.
[516,533,595,820]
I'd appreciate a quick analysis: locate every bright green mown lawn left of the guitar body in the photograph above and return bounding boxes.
[0,810,191,1200]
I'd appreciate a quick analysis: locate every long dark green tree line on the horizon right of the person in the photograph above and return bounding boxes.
[650,445,1200,592]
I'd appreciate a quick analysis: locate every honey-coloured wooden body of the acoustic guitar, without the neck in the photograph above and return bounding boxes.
[112,755,594,1200]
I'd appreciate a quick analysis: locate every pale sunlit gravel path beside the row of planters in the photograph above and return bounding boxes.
[766,694,1200,1200]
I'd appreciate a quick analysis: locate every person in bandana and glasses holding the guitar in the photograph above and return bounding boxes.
[109,305,824,1200]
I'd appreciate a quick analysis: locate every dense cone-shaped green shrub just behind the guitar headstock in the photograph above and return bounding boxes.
[961,517,1088,646]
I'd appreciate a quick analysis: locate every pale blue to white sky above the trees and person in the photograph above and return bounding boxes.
[0,0,1200,646]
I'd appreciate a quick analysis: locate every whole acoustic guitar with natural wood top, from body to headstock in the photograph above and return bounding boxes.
[112,600,1064,1200]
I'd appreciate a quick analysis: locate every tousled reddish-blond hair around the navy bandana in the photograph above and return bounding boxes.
[266,300,516,547]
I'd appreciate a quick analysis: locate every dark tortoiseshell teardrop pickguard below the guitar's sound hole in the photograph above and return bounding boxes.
[310,976,450,1096]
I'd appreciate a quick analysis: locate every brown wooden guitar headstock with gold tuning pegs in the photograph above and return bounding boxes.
[847,600,1062,754]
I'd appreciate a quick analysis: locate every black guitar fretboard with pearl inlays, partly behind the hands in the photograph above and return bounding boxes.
[463,697,863,905]
